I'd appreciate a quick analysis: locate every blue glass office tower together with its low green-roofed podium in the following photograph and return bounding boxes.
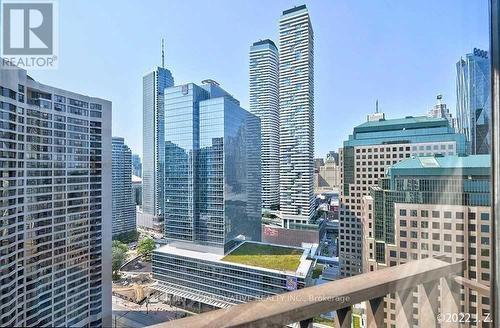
[153,80,304,307]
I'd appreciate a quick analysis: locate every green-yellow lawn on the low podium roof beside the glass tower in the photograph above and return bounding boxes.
[222,242,303,272]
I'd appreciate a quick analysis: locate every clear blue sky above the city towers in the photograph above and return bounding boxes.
[29,0,488,156]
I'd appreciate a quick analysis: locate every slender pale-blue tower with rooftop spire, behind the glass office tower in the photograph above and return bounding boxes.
[142,54,174,231]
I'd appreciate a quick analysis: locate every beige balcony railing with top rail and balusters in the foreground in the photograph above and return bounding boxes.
[152,258,476,328]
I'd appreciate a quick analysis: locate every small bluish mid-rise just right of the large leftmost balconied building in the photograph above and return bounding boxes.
[112,137,136,236]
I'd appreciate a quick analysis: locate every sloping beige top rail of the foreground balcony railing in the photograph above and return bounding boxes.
[153,258,466,328]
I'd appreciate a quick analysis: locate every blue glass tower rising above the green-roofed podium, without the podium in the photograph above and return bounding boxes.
[164,80,261,251]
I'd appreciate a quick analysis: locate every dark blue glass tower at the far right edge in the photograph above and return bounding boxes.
[457,48,491,154]
